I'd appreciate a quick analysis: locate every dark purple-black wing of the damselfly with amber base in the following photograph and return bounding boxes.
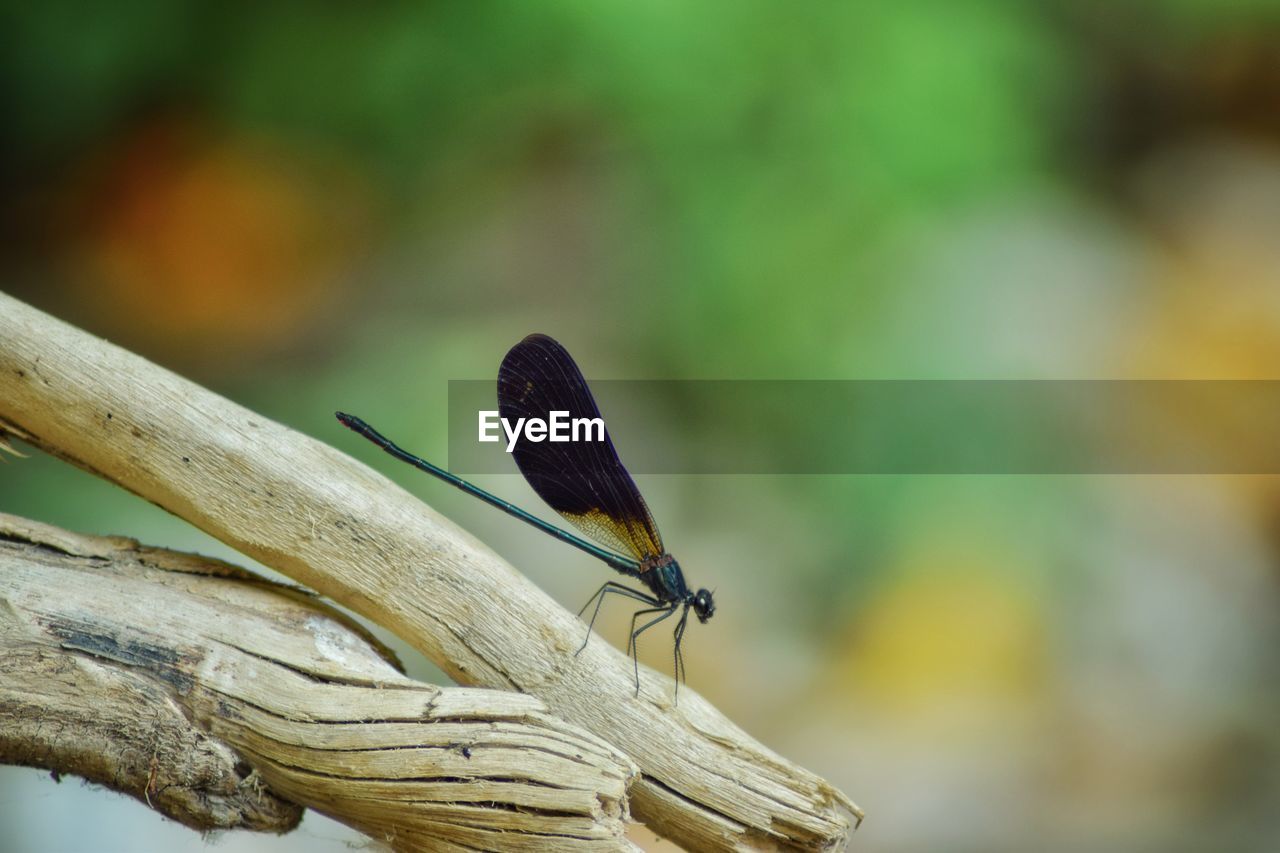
[498,334,666,561]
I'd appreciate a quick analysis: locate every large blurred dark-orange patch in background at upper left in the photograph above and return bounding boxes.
[77,123,361,361]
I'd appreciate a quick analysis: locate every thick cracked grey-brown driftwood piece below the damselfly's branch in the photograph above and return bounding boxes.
[0,514,636,850]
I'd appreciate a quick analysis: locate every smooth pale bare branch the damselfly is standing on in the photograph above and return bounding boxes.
[0,295,861,849]
